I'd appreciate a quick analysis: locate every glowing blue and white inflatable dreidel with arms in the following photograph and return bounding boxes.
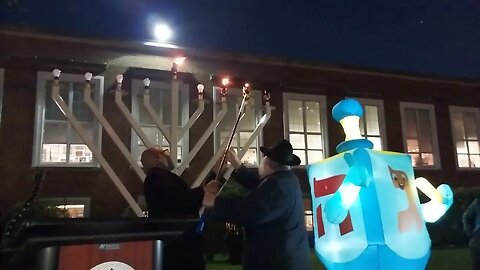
[307,99,453,270]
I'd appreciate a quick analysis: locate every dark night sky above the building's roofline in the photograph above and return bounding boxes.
[0,0,480,79]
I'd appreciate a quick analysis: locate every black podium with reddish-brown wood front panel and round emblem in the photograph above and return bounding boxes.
[2,218,199,270]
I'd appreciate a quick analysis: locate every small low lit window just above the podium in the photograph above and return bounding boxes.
[39,197,90,218]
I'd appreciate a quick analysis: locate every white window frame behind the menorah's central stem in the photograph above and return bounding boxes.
[130,79,190,167]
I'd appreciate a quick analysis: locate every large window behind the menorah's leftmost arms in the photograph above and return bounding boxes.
[33,72,103,167]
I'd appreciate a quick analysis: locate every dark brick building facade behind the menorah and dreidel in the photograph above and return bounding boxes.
[0,30,480,217]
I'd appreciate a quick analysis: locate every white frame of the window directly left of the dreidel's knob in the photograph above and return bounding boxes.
[283,92,329,168]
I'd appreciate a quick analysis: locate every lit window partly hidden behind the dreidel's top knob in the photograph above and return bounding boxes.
[355,98,387,151]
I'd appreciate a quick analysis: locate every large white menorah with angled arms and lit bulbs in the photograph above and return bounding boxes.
[52,63,273,217]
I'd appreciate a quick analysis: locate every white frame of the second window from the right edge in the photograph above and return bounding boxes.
[400,102,442,170]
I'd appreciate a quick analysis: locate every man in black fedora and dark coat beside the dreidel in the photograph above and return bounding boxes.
[203,140,311,270]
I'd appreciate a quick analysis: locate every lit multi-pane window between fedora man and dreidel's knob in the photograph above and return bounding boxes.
[283,93,327,165]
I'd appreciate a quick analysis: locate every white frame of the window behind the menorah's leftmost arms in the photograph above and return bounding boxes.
[32,71,104,168]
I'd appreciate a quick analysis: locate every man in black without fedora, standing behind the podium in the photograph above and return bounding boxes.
[141,148,218,270]
